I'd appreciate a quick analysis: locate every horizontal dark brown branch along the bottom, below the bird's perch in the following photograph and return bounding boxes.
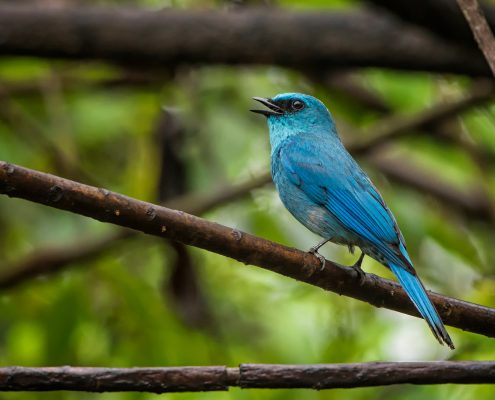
[0,361,495,393]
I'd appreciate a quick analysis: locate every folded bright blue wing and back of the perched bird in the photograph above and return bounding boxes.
[279,134,414,271]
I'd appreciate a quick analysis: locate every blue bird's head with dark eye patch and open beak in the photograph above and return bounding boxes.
[251,93,336,147]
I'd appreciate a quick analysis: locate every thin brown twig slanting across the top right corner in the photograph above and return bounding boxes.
[457,0,495,76]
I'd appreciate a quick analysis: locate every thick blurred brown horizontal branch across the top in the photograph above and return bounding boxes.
[0,5,489,76]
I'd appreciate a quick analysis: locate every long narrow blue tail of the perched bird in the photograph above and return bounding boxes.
[389,264,454,349]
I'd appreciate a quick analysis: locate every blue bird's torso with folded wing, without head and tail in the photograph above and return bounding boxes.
[272,132,412,268]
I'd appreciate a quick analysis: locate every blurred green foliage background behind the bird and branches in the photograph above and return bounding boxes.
[0,0,495,400]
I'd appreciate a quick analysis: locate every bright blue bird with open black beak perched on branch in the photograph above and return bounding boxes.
[251,93,454,349]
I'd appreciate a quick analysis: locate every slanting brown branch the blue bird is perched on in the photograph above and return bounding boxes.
[0,161,495,337]
